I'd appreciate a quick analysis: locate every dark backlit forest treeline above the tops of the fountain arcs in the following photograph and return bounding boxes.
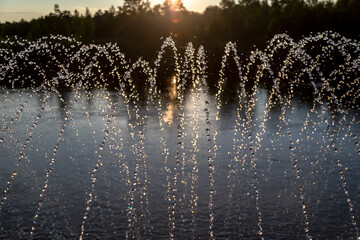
[0,0,360,60]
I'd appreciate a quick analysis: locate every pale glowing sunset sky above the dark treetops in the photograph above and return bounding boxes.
[0,0,220,22]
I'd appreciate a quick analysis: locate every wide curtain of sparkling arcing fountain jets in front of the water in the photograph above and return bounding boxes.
[0,32,360,239]
